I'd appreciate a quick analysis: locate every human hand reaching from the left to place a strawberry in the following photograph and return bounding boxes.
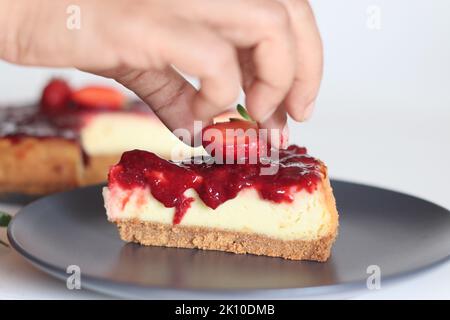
[0,0,322,147]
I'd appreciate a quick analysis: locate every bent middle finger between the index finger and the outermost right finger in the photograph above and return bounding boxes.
[191,0,296,122]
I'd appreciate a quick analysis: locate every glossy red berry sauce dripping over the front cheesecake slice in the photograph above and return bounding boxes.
[109,145,325,224]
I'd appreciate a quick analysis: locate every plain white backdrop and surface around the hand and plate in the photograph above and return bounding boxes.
[0,0,450,299]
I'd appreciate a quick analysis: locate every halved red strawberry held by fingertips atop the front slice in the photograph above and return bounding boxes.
[202,119,269,163]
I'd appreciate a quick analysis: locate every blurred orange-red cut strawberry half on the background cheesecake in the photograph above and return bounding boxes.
[71,86,125,110]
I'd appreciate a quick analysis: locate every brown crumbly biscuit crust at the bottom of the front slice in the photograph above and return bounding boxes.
[115,219,336,262]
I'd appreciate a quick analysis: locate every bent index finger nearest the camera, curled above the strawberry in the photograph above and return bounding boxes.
[161,24,241,125]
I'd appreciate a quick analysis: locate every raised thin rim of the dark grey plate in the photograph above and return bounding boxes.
[7,179,450,298]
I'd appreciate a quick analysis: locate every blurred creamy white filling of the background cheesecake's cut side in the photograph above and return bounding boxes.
[80,113,204,160]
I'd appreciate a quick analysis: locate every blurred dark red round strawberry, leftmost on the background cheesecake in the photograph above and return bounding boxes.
[41,79,72,115]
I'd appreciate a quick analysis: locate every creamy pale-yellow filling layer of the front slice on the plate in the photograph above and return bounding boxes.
[103,186,334,240]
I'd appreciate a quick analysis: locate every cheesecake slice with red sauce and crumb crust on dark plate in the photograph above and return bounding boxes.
[103,145,338,261]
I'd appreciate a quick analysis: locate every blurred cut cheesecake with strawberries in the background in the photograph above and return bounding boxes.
[0,79,204,195]
